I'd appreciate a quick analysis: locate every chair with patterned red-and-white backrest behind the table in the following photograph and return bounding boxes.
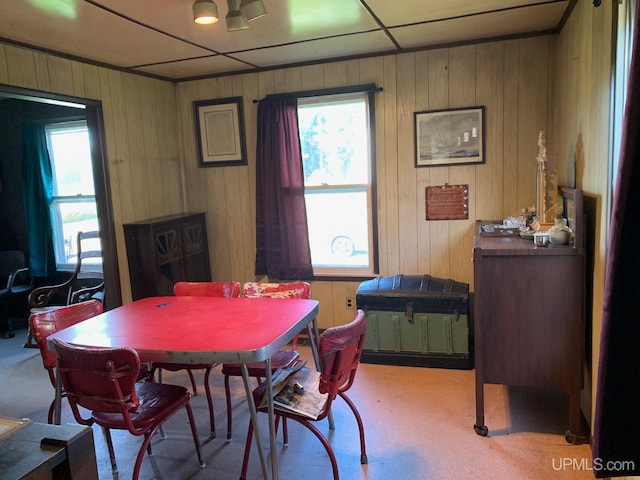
[222,282,311,441]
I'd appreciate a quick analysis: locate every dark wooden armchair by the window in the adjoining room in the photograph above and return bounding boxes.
[29,231,104,308]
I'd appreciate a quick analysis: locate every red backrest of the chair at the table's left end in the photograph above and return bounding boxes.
[29,300,104,384]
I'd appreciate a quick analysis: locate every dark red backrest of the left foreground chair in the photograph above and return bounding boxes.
[53,339,140,419]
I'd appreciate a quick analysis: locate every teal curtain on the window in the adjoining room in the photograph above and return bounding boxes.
[22,124,56,277]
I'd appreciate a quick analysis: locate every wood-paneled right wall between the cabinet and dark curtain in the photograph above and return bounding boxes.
[550,1,622,432]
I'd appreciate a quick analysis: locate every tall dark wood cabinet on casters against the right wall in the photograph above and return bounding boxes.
[473,188,585,442]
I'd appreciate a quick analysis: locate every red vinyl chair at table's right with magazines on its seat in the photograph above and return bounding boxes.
[240,310,368,480]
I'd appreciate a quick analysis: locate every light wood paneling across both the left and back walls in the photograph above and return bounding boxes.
[0,22,602,340]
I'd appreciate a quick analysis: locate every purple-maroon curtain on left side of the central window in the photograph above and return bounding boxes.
[255,96,313,280]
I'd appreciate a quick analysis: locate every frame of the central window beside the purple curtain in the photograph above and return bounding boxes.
[287,84,381,281]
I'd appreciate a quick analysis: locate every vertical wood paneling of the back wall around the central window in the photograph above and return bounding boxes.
[177,36,553,327]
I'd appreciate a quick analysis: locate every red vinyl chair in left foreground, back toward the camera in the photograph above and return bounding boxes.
[53,339,206,480]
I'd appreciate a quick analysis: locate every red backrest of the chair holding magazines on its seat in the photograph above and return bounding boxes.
[318,310,367,400]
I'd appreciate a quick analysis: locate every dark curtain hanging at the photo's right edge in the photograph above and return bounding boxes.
[592,0,640,478]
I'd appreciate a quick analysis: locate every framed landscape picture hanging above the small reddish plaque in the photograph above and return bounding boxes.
[415,106,484,167]
